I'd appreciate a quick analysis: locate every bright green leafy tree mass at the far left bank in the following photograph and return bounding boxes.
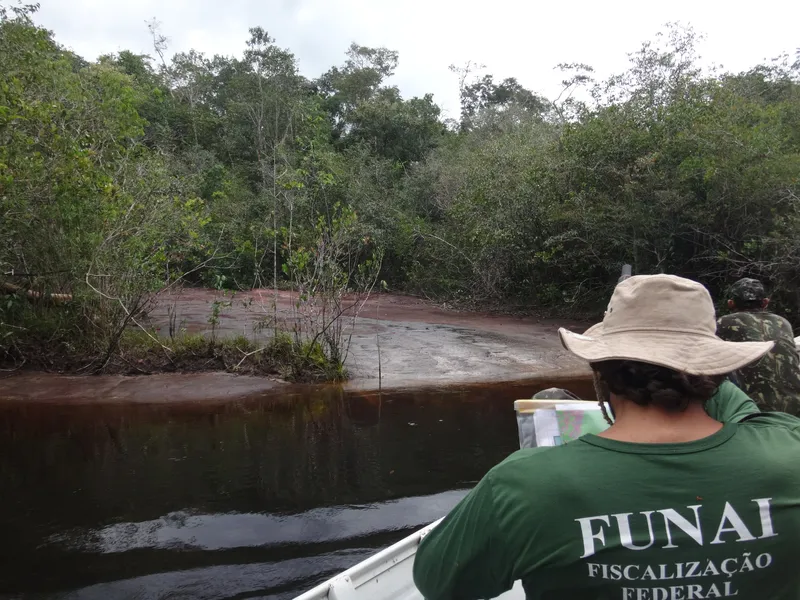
[0,5,209,367]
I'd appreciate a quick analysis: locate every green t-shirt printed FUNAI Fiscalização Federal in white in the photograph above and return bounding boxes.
[414,384,800,600]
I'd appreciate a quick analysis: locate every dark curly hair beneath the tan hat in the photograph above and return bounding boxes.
[591,360,724,412]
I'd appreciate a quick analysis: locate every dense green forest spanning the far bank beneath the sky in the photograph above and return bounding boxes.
[0,5,800,378]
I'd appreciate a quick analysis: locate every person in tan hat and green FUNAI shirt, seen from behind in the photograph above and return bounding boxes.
[414,275,800,600]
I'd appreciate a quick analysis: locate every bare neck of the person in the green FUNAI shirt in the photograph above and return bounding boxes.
[599,398,722,444]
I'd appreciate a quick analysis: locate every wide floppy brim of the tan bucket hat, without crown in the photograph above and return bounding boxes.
[558,323,775,375]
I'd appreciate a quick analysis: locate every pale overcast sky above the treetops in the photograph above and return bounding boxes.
[36,0,800,117]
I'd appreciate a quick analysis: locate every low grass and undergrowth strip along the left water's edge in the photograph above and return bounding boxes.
[0,296,347,382]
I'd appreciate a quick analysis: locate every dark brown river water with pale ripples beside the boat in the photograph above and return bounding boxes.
[0,380,591,600]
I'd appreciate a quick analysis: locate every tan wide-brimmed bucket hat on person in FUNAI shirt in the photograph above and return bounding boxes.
[558,275,774,375]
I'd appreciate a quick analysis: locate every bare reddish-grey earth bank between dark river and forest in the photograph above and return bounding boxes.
[0,289,588,404]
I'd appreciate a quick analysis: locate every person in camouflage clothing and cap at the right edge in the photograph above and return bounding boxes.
[717,278,800,416]
